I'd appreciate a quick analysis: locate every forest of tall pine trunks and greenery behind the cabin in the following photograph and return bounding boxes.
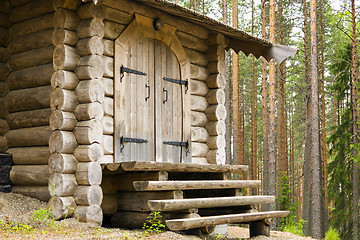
[171,0,360,239]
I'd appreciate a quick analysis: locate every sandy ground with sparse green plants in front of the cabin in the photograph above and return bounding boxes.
[0,192,312,240]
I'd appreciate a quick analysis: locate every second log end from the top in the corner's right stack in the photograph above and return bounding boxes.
[77,18,104,38]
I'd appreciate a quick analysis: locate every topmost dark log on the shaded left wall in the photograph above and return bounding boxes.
[10,0,54,23]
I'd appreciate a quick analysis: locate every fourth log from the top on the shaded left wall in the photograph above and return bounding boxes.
[8,46,54,71]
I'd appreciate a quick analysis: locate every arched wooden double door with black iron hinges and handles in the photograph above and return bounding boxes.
[118,38,188,162]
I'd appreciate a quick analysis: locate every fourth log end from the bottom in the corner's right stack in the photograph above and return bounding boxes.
[74,143,104,162]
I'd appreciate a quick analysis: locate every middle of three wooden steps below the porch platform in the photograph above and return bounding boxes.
[148,196,275,211]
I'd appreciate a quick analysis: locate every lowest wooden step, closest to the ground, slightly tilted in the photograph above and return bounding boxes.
[166,211,290,231]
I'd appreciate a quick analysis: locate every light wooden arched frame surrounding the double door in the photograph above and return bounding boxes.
[114,13,191,163]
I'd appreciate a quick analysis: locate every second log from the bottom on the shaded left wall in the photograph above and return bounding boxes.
[10,165,50,186]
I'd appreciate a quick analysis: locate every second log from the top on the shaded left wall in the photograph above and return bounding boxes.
[9,13,54,38]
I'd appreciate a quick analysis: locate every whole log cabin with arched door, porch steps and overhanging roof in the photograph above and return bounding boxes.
[0,0,296,235]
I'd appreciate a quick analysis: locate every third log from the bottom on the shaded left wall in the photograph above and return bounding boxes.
[7,146,50,165]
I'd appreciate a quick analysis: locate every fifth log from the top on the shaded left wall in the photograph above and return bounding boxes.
[6,64,54,90]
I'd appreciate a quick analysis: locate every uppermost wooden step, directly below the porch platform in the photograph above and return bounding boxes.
[134,180,261,191]
